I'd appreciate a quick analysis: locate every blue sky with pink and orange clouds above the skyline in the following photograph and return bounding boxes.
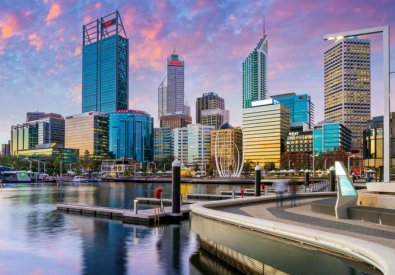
[0,0,395,147]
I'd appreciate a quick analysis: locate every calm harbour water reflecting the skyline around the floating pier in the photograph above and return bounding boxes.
[0,183,249,275]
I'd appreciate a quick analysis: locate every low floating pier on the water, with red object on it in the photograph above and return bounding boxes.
[56,203,190,225]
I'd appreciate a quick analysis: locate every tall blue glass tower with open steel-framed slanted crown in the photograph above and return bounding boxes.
[82,11,129,113]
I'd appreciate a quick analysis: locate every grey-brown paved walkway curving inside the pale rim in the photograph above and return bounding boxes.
[216,198,395,249]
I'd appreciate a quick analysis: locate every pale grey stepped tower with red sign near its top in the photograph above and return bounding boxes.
[158,50,190,118]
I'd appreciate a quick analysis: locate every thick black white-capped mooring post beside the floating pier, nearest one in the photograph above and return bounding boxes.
[170,159,182,223]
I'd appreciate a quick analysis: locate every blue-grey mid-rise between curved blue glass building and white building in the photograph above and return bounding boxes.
[154,127,174,162]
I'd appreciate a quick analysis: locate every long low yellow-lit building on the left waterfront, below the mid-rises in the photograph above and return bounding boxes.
[18,147,79,164]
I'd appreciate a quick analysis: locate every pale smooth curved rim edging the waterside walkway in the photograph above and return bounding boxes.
[190,195,395,274]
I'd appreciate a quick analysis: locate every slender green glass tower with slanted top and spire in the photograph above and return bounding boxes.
[243,33,268,109]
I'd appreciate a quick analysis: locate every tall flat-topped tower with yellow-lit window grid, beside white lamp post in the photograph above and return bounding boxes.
[324,38,371,152]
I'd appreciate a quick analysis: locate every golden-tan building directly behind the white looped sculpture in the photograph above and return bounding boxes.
[211,123,243,175]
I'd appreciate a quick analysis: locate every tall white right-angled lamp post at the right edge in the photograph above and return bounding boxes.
[324,26,391,182]
